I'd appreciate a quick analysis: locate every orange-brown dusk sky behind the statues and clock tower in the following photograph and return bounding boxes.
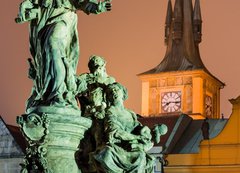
[0,0,240,124]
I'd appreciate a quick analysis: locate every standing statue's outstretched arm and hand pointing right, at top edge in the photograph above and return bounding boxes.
[77,0,111,14]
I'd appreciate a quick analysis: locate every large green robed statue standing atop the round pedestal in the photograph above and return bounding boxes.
[16,0,111,109]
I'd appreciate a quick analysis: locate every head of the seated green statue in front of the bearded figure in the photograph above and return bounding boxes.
[106,82,128,103]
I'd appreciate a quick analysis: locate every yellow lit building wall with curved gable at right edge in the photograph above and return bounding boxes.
[165,96,240,173]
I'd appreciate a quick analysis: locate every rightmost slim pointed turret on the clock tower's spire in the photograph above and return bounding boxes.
[193,0,202,43]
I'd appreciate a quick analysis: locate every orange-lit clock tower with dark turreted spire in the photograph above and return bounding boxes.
[138,0,224,119]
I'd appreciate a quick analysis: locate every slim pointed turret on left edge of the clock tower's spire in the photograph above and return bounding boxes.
[165,0,173,45]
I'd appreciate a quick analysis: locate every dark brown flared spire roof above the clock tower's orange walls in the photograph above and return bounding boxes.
[142,0,210,74]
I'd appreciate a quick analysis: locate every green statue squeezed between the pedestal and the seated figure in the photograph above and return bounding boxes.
[77,55,115,173]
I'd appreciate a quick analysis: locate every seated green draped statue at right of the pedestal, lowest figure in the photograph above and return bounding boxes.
[93,83,154,173]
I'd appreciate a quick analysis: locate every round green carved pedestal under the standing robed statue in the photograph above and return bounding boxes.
[17,106,92,173]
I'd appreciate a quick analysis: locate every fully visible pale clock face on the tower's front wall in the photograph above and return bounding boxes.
[161,91,181,113]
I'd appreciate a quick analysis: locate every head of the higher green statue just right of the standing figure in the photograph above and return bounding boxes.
[88,55,106,73]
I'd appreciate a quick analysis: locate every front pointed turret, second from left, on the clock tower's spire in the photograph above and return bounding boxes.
[173,0,183,40]
